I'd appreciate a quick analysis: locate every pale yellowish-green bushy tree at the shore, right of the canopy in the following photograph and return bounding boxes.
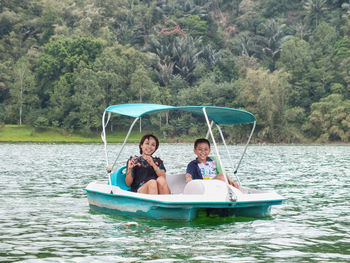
[234,69,296,142]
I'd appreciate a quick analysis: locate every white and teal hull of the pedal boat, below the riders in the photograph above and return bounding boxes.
[84,179,286,221]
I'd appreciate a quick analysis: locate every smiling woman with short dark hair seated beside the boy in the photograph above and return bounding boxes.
[125,134,170,194]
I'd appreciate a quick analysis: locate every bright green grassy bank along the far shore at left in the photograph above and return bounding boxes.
[0,124,194,143]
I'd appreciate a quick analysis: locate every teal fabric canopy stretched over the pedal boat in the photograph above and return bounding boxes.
[106,104,256,124]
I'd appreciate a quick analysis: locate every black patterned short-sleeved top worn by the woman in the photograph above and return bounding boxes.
[128,157,165,192]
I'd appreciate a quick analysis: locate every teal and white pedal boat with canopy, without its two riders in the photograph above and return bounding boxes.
[84,104,287,221]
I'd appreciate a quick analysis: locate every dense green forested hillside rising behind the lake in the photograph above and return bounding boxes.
[0,0,350,143]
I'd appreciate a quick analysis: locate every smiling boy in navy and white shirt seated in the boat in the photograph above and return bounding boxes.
[186,138,241,189]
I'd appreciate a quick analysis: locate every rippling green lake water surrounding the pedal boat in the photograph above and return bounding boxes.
[0,144,350,262]
